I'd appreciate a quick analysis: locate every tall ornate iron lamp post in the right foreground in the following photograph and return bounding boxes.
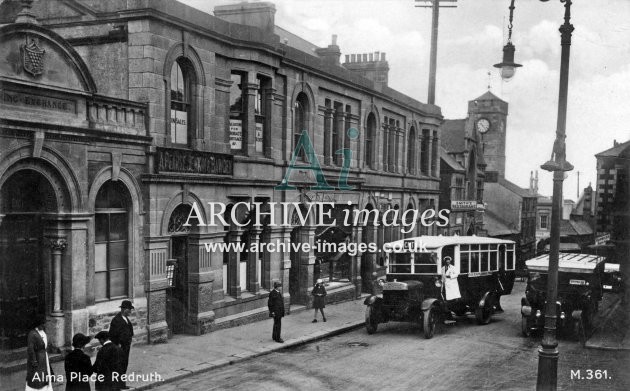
[504,0,573,391]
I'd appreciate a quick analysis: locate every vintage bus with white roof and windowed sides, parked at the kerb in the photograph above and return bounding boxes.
[365,236,515,338]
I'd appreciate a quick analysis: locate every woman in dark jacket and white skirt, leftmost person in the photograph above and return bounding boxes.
[25,315,54,391]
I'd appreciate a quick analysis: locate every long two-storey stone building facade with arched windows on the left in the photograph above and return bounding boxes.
[0,0,442,355]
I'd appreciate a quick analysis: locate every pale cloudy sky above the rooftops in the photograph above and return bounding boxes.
[180,0,630,200]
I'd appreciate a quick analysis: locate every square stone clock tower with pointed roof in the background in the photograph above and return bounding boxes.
[468,91,508,178]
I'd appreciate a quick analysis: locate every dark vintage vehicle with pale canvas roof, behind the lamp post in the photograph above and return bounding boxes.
[521,253,604,340]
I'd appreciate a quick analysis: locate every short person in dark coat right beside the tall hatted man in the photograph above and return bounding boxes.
[93,331,124,391]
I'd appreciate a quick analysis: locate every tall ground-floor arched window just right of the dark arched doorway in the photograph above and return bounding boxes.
[94,181,131,301]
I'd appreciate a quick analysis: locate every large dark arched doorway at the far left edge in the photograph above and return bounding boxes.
[0,169,58,349]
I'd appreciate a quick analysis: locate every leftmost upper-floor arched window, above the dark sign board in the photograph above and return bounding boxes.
[169,57,194,145]
